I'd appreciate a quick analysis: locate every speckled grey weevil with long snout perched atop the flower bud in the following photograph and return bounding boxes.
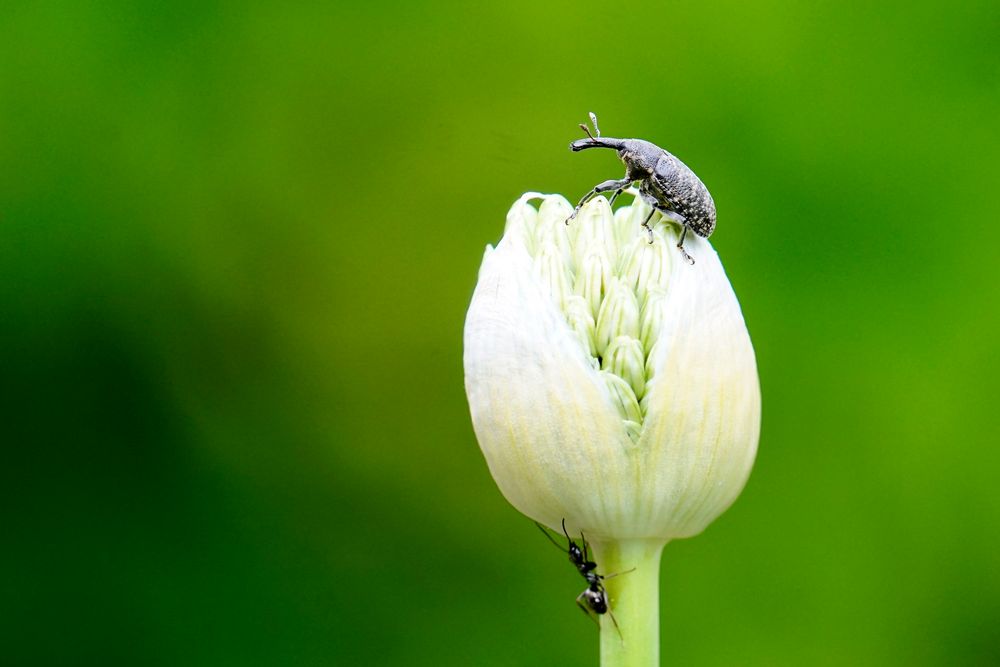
[566,113,715,264]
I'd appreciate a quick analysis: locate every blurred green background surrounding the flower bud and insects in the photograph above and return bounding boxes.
[0,1,1000,666]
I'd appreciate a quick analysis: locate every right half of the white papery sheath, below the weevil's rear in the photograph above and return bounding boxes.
[636,235,760,537]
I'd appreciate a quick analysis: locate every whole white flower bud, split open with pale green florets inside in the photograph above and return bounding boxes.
[465,193,760,541]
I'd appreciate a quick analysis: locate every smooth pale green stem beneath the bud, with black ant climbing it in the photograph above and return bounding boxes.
[590,540,665,667]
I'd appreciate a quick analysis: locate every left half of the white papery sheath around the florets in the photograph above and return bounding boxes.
[465,235,632,537]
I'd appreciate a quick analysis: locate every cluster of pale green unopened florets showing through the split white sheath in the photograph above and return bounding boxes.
[505,197,672,443]
